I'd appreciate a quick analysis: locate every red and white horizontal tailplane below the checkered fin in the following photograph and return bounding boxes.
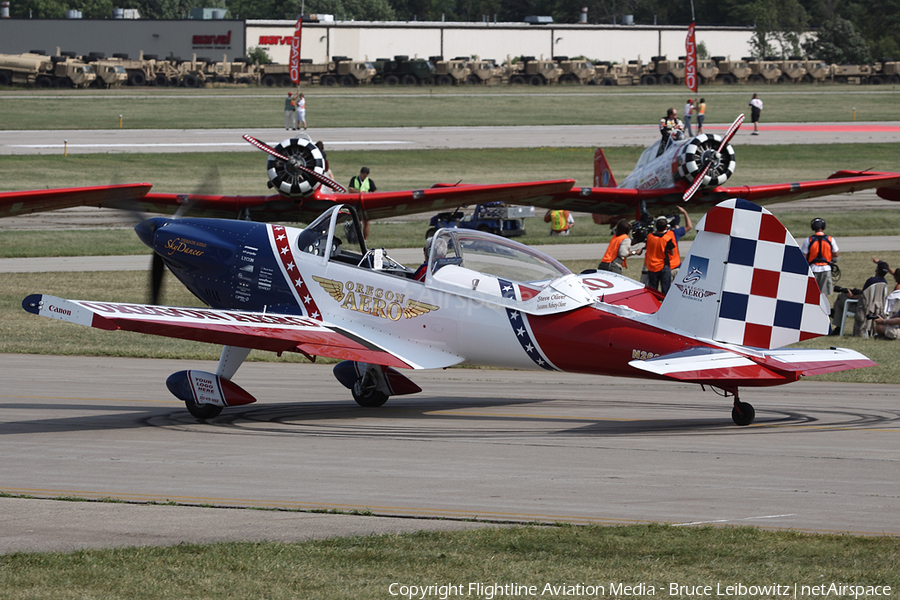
[628,348,875,386]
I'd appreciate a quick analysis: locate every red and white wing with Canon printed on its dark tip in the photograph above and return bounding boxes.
[22,294,463,369]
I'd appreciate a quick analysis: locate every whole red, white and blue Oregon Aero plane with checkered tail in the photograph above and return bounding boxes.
[23,199,874,425]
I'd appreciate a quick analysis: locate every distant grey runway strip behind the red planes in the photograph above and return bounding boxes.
[0,121,900,155]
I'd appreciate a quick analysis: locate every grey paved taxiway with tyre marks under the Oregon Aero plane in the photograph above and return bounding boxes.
[0,354,900,552]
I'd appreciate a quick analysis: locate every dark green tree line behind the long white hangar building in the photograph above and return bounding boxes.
[10,0,900,64]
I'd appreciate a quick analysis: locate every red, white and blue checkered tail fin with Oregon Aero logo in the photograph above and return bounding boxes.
[656,199,830,349]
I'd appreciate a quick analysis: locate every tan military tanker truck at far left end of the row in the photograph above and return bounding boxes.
[0,51,96,89]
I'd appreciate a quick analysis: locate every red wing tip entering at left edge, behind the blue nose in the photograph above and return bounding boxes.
[0,183,153,218]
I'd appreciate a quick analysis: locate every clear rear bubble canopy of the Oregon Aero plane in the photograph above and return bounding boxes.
[428,229,571,282]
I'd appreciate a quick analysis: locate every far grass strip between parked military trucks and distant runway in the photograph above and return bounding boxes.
[0,84,900,130]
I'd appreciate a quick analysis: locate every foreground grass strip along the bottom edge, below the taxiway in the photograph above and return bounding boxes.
[0,525,900,600]
